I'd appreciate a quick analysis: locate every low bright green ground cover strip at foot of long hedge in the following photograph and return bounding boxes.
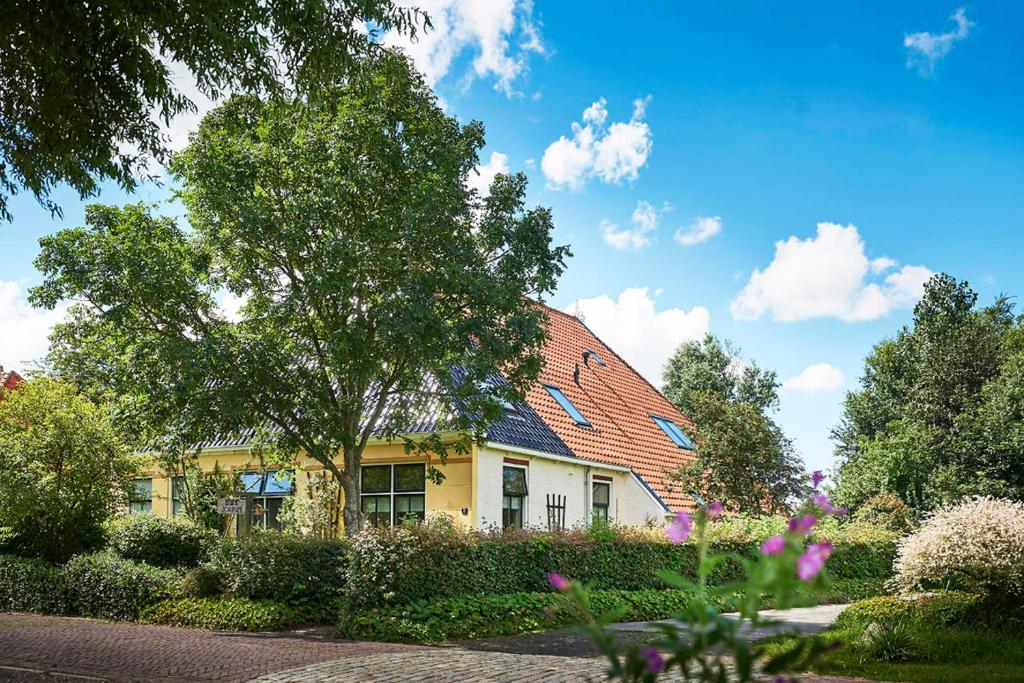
[337,590,690,643]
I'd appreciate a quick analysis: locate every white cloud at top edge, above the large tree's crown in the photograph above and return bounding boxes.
[382,0,545,97]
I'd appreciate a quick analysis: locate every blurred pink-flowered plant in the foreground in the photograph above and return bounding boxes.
[549,472,860,682]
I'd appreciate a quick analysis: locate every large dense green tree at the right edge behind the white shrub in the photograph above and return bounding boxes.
[834,273,1024,510]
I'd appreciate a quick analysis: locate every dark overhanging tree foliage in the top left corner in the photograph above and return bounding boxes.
[0,0,429,220]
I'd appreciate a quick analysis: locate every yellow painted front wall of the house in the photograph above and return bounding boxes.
[131,443,476,526]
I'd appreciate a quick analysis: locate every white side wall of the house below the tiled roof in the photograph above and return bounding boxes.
[474,444,665,528]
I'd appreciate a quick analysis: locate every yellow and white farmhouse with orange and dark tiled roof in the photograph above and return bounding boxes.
[131,310,695,528]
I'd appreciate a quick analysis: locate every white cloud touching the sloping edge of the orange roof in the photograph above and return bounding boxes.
[567,287,711,386]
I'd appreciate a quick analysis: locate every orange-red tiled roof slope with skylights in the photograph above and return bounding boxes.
[526,308,693,509]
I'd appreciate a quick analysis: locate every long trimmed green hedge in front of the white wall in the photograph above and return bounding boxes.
[346,526,895,609]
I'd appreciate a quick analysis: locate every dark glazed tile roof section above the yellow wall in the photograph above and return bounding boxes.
[197,370,574,458]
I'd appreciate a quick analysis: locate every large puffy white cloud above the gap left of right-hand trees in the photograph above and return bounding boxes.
[730,223,932,322]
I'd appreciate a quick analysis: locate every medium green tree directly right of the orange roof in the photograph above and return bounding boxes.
[665,334,806,513]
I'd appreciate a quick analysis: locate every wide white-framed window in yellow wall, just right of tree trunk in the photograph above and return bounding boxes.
[360,463,427,526]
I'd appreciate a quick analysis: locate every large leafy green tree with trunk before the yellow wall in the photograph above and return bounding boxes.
[32,52,568,532]
